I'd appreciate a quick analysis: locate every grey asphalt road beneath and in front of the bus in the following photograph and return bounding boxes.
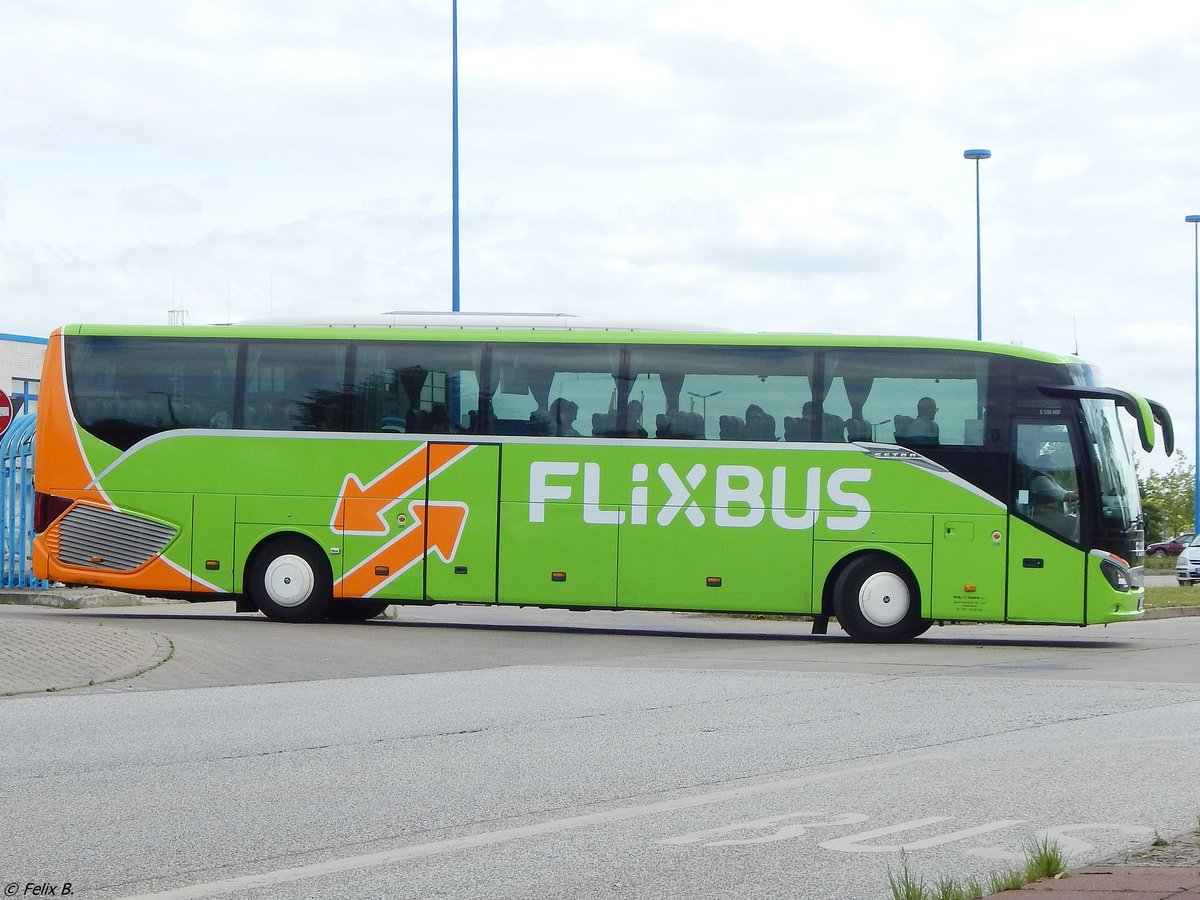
[0,606,1200,898]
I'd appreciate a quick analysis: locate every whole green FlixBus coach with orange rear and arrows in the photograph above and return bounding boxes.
[34,313,1172,641]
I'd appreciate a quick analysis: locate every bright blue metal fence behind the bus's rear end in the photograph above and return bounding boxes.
[0,415,48,588]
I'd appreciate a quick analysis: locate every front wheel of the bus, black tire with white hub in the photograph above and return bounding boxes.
[833,553,930,643]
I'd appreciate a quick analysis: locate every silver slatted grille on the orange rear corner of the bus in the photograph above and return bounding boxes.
[58,506,176,571]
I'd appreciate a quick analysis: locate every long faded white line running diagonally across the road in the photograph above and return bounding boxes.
[112,754,950,900]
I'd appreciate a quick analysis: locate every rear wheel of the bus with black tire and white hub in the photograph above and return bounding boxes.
[246,536,334,622]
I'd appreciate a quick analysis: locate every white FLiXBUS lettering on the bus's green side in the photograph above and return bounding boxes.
[529,462,871,532]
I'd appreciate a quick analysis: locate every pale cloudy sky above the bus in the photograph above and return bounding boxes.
[0,0,1200,469]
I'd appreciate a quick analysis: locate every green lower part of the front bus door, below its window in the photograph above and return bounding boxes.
[1006,516,1087,625]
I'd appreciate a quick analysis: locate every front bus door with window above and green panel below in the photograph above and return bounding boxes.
[1006,419,1087,624]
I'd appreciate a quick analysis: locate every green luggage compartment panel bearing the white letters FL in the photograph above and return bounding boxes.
[498,442,628,607]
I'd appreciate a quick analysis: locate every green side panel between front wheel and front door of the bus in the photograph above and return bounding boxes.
[930,512,1008,622]
